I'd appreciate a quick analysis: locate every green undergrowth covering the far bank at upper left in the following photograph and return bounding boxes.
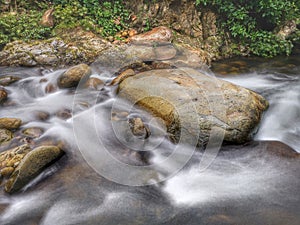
[0,0,129,49]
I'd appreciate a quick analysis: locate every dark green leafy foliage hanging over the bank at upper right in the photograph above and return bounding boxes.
[196,0,300,57]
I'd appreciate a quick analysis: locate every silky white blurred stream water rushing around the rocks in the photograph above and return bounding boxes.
[0,57,300,225]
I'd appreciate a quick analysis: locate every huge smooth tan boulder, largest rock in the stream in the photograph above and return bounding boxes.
[118,68,268,146]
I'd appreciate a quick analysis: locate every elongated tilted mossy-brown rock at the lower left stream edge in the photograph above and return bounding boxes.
[5,146,63,194]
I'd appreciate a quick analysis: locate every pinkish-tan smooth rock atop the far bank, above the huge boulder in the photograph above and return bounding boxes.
[129,26,172,44]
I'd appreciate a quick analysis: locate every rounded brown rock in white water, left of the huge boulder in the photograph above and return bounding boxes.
[57,64,92,88]
